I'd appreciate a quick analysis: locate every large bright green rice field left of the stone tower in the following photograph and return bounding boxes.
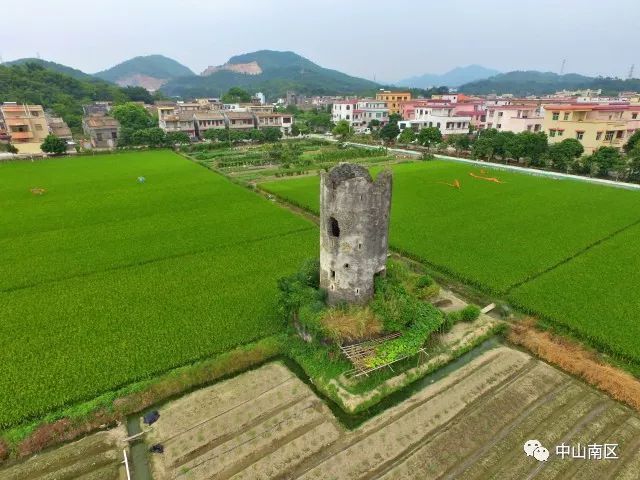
[0,151,318,427]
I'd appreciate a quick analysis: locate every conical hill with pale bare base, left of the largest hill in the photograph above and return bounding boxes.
[95,55,195,90]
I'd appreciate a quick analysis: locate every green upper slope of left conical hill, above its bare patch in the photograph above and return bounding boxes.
[95,55,195,82]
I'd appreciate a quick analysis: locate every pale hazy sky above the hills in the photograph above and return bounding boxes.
[0,0,640,81]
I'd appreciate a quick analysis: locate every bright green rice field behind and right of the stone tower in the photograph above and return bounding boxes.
[261,161,640,364]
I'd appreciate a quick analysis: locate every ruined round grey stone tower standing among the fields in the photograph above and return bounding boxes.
[320,163,391,305]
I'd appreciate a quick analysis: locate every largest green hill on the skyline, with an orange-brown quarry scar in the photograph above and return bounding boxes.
[162,50,379,98]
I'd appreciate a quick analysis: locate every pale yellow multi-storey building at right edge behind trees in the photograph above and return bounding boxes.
[542,104,637,154]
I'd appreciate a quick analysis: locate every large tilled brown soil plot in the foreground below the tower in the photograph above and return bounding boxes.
[139,347,640,480]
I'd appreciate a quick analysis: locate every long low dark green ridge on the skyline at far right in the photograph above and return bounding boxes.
[458,70,640,96]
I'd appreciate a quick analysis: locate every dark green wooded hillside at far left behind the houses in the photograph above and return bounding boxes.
[0,63,153,128]
